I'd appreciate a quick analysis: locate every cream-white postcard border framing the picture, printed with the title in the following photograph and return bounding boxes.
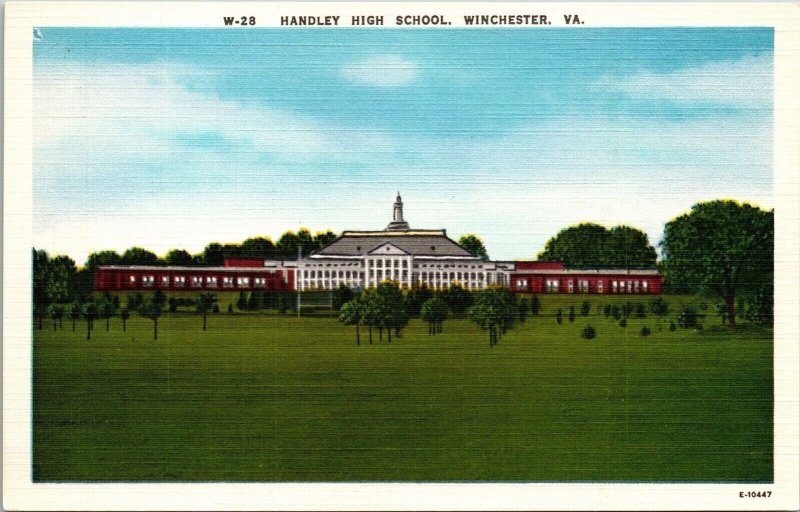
[3,2,800,510]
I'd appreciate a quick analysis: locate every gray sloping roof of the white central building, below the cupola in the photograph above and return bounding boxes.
[311,230,477,258]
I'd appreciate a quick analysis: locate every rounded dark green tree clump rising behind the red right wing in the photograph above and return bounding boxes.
[538,223,656,268]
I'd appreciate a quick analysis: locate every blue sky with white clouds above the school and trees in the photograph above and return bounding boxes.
[33,27,774,264]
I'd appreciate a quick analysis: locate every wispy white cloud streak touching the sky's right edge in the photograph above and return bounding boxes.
[597,55,773,107]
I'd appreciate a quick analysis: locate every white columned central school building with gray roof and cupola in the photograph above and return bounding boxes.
[288,194,514,290]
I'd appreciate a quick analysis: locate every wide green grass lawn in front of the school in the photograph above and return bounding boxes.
[33,297,773,481]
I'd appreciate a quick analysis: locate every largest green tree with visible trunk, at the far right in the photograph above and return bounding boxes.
[661,200,775,325]
